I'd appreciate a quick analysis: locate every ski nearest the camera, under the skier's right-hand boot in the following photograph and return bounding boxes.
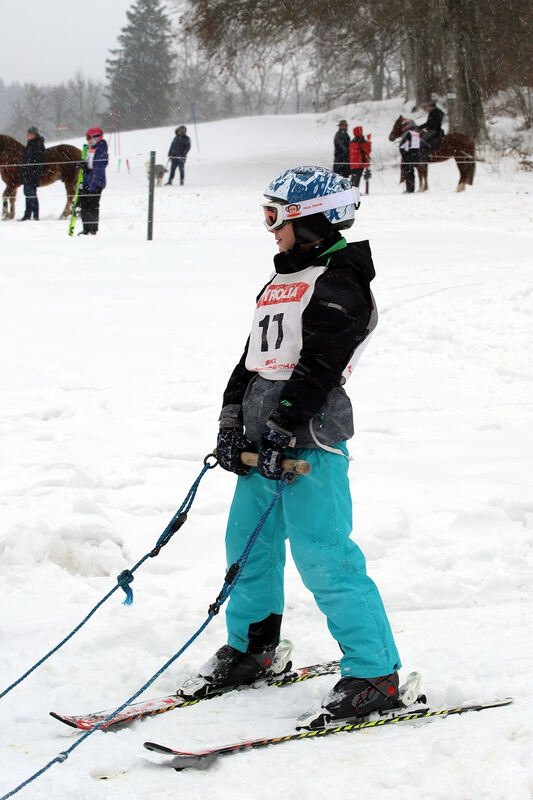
[144,697,513,772]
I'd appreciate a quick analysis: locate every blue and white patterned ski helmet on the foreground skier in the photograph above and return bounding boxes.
[263,166,360,241]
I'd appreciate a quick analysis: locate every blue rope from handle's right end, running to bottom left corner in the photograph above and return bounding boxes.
[0,477,291,800]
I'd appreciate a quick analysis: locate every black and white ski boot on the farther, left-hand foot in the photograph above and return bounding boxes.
[180,639,292,700]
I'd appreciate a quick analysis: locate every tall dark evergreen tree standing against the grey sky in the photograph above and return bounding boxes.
[106,0,176,129]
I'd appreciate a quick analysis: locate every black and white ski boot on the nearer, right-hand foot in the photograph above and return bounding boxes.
[297,672,422,729]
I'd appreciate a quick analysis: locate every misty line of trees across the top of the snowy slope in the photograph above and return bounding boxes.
[0,0,533,141]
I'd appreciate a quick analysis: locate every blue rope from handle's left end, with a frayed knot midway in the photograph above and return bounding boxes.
[0,457,216,700]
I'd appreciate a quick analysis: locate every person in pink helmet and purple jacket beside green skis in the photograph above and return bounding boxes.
[78,127,109,236]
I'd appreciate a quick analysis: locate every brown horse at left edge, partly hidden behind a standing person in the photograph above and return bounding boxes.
[0,134,81,219]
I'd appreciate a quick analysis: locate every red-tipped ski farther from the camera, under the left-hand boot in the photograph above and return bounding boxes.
[50,661,339,731]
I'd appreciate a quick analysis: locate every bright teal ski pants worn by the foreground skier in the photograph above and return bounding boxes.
[226,443,400,678]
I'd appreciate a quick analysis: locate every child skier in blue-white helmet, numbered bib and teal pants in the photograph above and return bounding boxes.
[179,167,400,727]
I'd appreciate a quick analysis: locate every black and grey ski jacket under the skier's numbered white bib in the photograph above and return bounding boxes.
[222,233,376,448]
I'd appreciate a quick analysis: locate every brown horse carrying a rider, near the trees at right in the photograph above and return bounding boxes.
[389,115,476,192]
